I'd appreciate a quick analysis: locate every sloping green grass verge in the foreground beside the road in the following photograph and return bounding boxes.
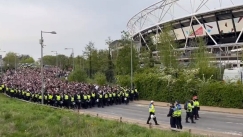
[0,94,199,137]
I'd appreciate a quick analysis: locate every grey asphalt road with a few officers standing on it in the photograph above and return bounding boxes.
[86,103,243,135]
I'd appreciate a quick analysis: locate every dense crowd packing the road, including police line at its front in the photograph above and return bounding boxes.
[0,68,138,109]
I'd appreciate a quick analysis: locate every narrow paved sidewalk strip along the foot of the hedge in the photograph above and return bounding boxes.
[134,100,243,115]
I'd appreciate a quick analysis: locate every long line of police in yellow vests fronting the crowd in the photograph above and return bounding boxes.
[0,85,138,109]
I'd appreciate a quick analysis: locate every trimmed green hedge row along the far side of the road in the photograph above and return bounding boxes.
[117,73,243,108]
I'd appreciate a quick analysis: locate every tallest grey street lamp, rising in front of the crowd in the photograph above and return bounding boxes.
[39,31,57,104]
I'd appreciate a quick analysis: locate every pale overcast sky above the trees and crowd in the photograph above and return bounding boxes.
[0,0,239,59]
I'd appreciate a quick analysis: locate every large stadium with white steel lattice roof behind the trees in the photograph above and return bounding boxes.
[127,0,243,62]
